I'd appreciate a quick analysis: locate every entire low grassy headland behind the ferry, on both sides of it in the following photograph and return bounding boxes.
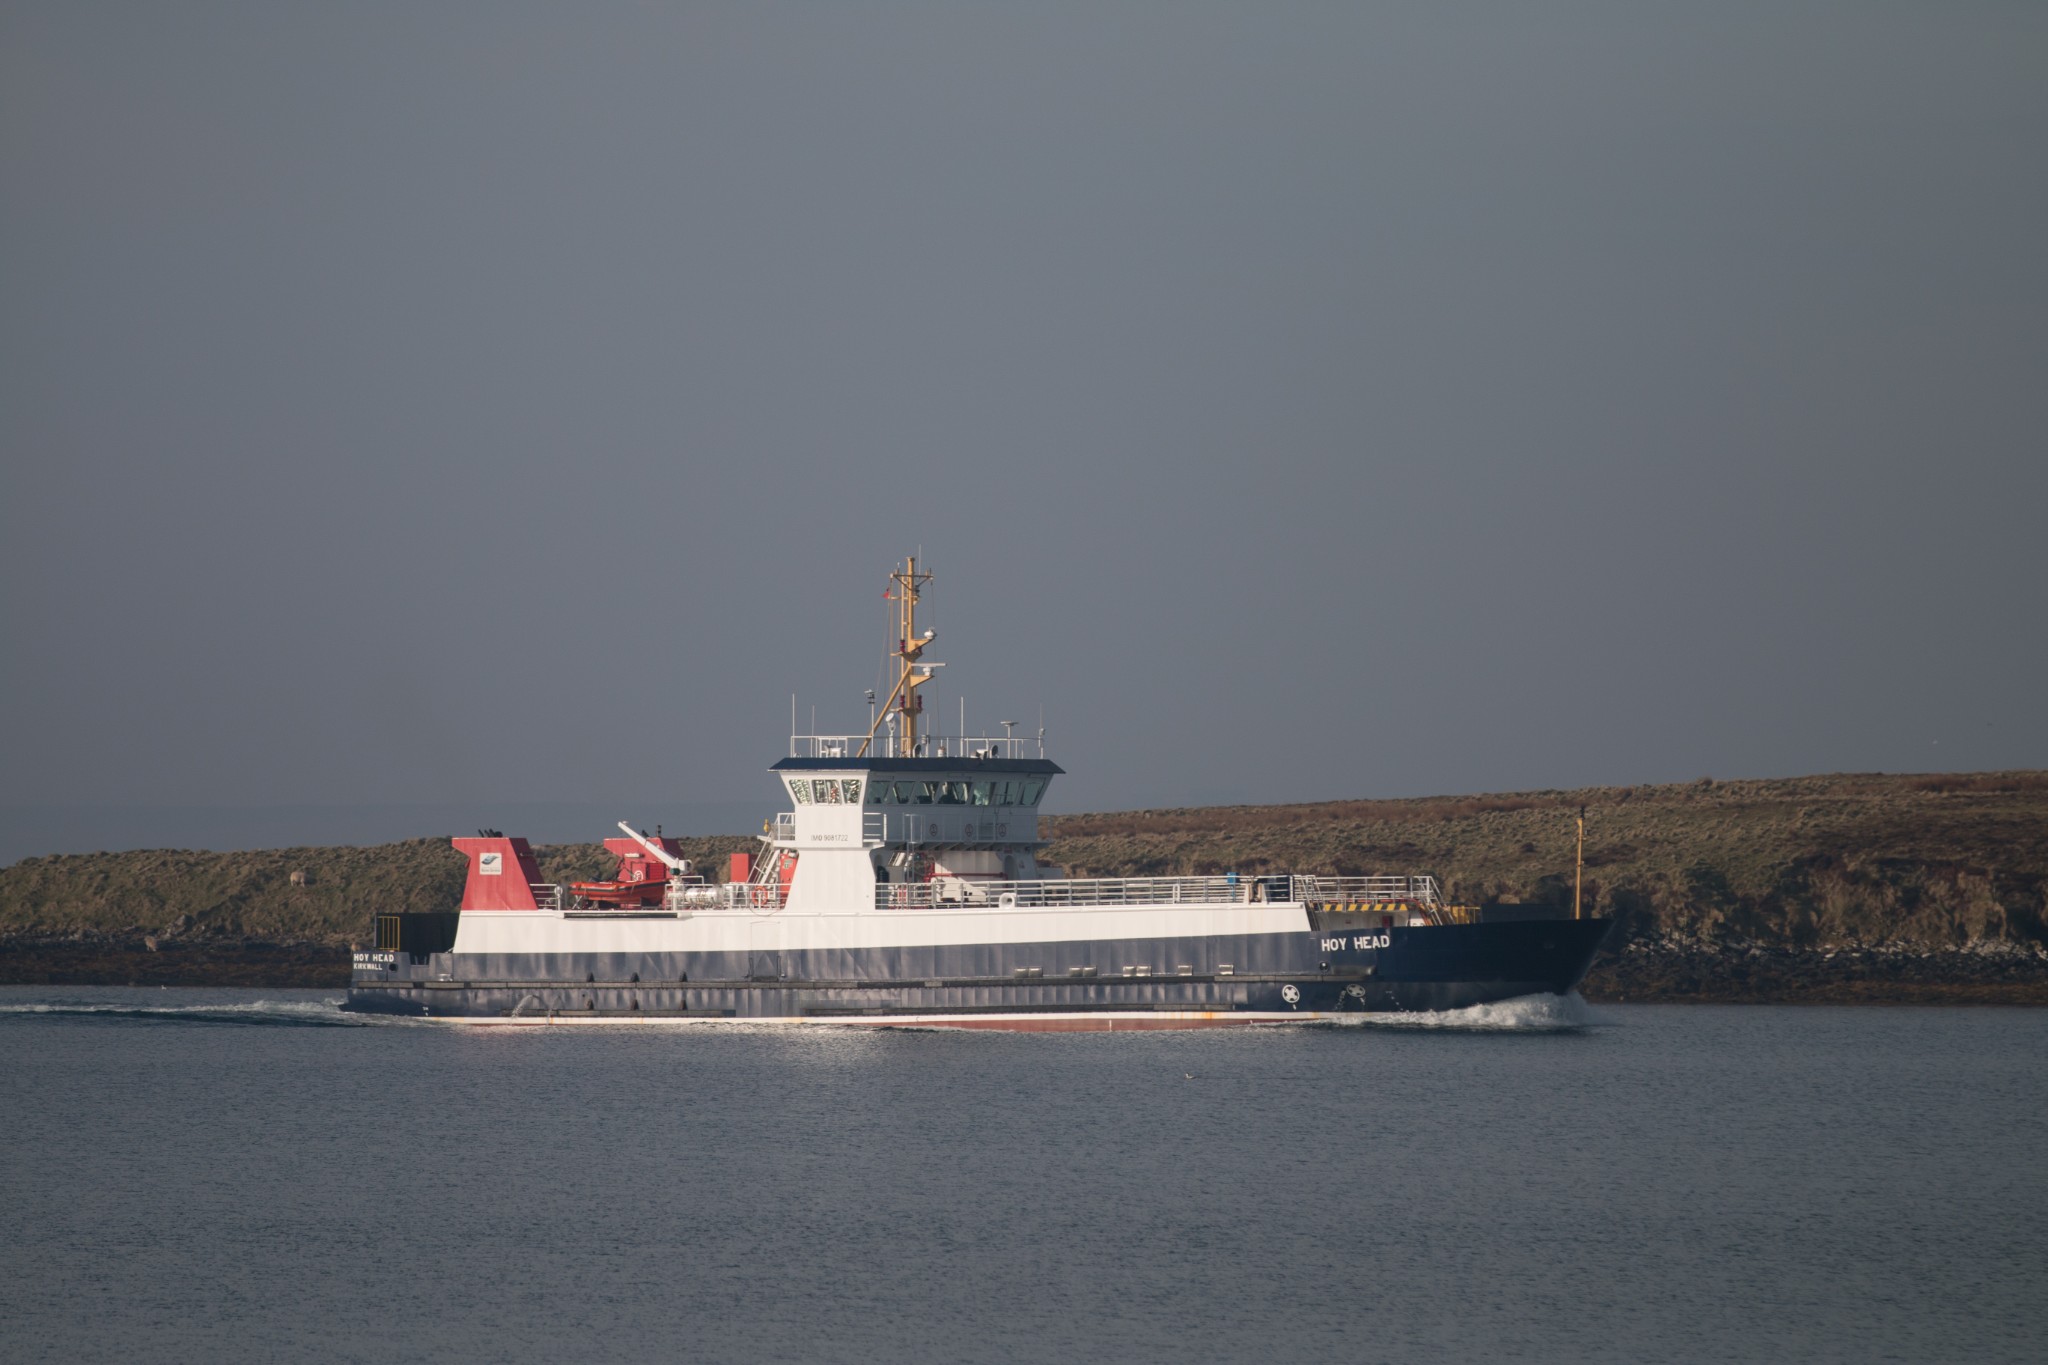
[0,772,2048,1003]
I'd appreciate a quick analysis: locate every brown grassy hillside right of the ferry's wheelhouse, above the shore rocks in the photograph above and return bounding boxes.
[1049,772,2048,948]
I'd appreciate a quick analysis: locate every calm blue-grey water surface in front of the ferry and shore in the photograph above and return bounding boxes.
[0,988,2048,1365]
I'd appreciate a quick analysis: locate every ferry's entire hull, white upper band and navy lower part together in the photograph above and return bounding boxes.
[348,905,1608,1031]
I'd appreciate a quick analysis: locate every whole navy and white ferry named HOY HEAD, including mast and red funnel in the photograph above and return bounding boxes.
[344,557,1610,1031]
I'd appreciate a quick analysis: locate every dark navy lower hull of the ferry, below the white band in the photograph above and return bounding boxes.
[344,915,1610,1027]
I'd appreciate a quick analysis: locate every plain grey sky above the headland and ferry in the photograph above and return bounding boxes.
[0,0,2048,855]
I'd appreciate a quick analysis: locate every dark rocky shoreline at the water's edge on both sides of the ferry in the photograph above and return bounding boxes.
[0,933,2048,1005]
